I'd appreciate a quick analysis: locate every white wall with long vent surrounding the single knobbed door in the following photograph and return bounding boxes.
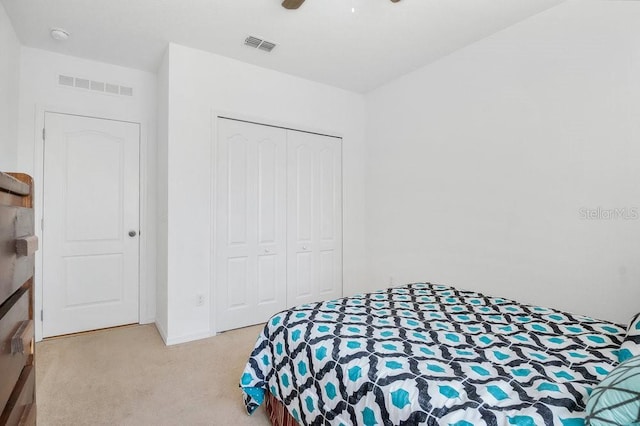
[17,47,157,338]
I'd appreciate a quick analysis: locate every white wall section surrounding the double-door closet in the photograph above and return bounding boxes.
[158,44,366,343]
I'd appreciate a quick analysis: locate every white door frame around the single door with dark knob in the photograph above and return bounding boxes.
[33,105,155,342]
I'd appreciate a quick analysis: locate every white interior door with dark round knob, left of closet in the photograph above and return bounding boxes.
[42,113,140,337]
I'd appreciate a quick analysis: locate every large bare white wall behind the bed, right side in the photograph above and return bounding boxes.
[367,1,640,323]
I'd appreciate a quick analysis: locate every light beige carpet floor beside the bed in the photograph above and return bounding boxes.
[36,325,270,426]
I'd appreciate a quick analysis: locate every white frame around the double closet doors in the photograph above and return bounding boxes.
[209,108,345,336]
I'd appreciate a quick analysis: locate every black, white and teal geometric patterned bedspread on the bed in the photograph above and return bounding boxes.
[240,283,625,426]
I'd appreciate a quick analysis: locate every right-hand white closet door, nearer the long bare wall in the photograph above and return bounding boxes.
[287,131,342,307]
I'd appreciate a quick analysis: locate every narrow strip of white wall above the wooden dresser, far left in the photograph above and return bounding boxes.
[0,3,20,171]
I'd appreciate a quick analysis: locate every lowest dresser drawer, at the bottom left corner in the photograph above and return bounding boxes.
[0,365,36,426]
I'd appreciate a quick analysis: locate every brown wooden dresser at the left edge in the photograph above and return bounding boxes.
[0,172,38,425]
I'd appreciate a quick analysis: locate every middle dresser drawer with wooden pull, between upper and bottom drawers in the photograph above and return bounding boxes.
[0,288,33,414]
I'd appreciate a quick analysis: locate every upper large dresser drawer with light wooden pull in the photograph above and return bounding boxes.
[0,206,35,304]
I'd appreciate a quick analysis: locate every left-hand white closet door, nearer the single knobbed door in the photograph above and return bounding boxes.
[214,118,287,331]
